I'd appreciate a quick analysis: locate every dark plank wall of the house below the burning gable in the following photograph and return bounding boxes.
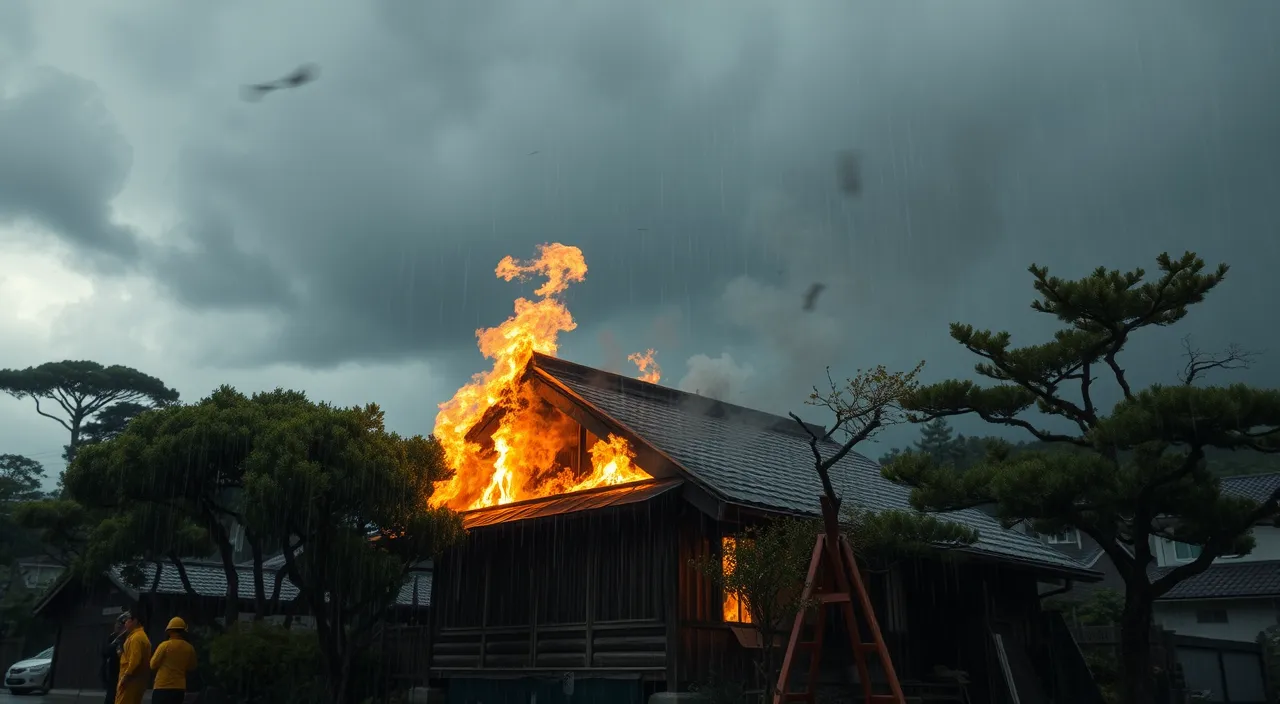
[430,493,684,678]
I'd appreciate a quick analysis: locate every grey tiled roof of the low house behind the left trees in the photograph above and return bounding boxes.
[110,561,431,607]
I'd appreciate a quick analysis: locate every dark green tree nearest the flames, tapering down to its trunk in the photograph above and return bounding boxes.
[235,390,462,700]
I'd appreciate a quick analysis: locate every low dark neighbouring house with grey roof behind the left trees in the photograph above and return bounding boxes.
[36,557,431,690]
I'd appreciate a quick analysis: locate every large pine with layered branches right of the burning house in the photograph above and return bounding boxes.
[883,252,1280,704]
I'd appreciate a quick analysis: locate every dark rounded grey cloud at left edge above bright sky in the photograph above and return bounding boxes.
[0,68,137,265]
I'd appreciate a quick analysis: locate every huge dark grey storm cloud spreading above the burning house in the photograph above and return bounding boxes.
[15,1,1280,393]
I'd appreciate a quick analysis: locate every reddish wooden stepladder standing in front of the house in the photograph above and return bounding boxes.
[773,497,905,704]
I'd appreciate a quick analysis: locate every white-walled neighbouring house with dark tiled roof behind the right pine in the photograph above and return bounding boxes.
[1028,472,1280,643]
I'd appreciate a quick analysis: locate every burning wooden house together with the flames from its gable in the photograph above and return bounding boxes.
[398,244,1098,703]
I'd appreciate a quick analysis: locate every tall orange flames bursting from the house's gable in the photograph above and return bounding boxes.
[431,243,657,511]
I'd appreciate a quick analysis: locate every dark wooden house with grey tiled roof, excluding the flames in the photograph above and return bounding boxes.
[417,356,1098,704]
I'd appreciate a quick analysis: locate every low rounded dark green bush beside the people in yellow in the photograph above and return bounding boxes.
[207,623,324,704]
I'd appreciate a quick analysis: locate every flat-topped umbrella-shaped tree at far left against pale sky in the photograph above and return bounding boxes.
[0,360,178,460]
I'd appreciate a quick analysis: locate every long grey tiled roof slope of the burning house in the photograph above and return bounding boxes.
[535,355,1084,572]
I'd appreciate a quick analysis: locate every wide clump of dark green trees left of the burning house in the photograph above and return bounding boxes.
[31,387,462,698]
